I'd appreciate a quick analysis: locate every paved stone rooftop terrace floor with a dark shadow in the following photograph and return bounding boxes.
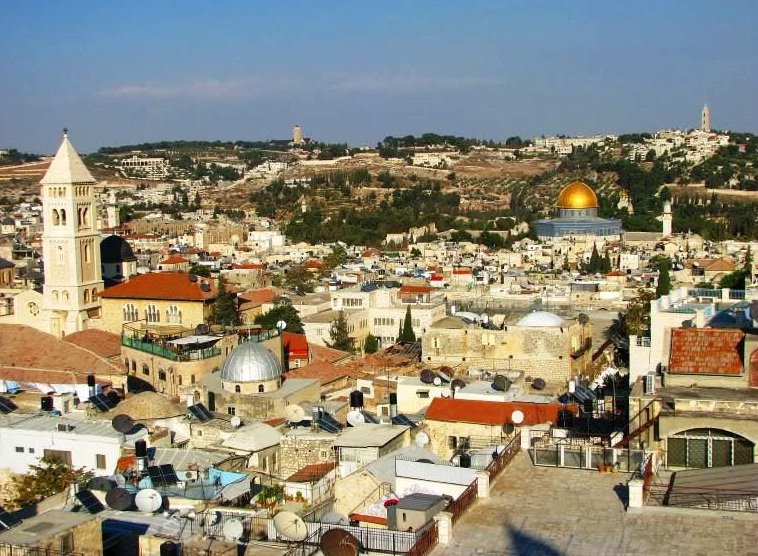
[432,452,758,556]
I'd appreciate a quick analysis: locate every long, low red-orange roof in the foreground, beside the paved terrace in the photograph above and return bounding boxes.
[425,398,578,426]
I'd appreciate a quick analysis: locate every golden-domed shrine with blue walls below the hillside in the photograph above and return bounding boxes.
[534,181,621,241]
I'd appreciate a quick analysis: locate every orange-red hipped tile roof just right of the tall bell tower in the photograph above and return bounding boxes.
[100,272,216,301]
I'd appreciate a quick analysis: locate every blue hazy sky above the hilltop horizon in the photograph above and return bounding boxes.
[0,0,758,153]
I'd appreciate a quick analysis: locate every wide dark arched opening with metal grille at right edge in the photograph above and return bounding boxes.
[666,429,755,469]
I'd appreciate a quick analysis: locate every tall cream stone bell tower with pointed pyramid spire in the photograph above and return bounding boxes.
[40,129,103,337]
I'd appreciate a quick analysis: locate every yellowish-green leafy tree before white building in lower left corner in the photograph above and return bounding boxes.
[6,456,92,509]
